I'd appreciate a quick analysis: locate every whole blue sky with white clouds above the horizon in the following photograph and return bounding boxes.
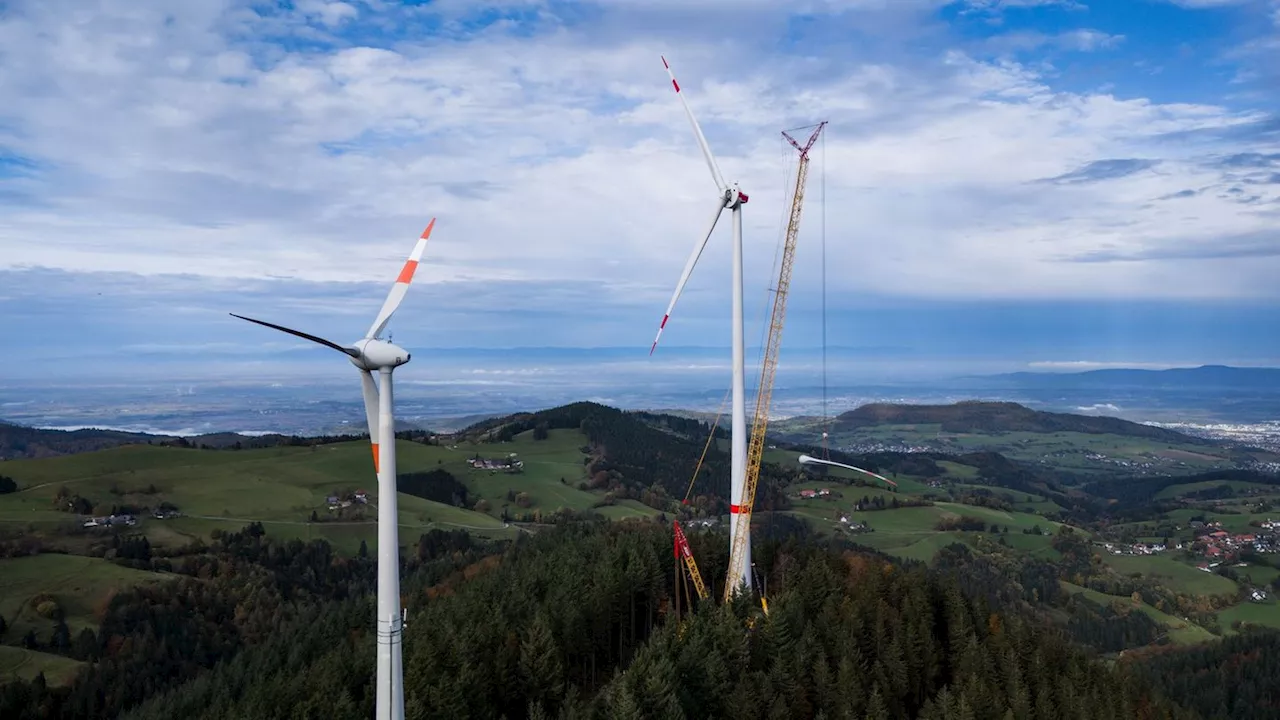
[0,0,1280,382]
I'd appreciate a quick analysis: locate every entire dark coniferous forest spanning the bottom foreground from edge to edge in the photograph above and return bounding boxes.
[0,520,1280,720]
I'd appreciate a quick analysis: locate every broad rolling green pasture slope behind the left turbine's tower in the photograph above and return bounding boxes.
[0,430,614,552]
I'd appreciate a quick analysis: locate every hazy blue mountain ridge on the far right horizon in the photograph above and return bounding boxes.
[965,365,1280,389]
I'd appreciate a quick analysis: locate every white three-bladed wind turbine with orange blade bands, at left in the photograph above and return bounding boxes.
[230,218,435,720]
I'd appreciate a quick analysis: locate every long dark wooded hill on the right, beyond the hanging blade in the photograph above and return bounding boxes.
[835,400,1213,445]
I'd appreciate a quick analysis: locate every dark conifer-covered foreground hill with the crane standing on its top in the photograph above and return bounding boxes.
[92,524,1194,720]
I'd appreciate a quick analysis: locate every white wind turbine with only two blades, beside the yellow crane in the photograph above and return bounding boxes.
[649,58,751,589]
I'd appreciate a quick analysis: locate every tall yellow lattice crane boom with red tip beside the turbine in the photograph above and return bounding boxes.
[724,120,827,602]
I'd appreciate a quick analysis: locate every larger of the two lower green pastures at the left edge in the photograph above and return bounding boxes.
[0,553,177,643]
